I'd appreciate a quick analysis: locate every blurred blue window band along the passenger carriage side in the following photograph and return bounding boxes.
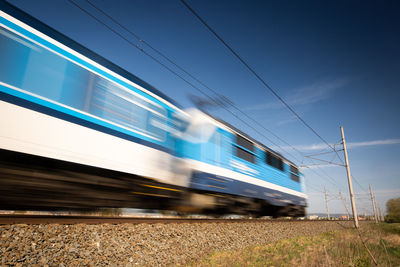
[0,26,168,141]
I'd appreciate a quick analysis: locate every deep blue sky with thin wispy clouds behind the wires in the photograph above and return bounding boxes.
[9,0,400,214]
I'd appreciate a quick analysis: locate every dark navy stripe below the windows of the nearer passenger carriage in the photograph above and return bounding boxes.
[0,91,171,153]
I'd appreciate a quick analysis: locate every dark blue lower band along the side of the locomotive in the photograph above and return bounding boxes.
[189,171,306,206]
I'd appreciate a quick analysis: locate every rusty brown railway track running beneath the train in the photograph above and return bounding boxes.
[0,214,328,225]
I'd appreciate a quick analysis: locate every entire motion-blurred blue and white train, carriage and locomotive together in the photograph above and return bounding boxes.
[0,2,307,217]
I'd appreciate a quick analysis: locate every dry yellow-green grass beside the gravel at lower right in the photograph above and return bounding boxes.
[193,224,400,267]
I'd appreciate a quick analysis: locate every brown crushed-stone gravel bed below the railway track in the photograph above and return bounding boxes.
[0,221,352,266]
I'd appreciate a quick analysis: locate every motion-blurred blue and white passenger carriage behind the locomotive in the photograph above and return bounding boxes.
[0,1,188,211]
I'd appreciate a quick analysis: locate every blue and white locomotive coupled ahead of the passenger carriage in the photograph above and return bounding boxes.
[178,110,307,217]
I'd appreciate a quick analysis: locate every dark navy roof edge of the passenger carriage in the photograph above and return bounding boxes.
[0,0,182,109]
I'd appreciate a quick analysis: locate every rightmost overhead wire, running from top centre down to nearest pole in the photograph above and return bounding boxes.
[181,0,341,165]
